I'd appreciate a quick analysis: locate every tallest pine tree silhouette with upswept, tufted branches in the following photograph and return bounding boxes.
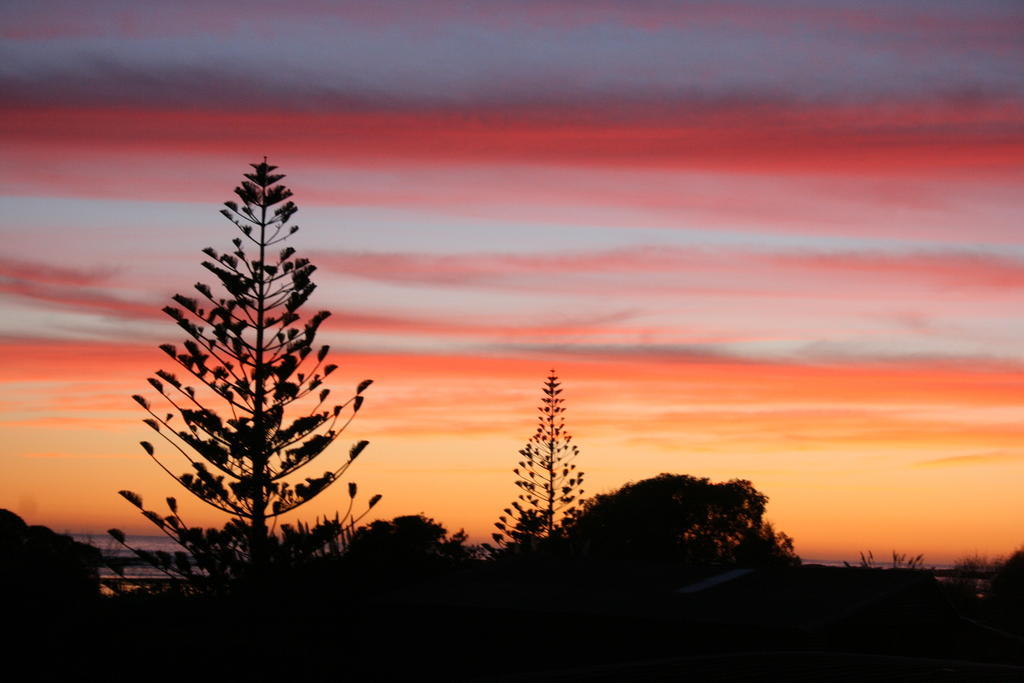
[111,159,380,581]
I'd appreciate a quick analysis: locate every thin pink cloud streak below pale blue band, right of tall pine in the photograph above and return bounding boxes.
[312,246,1024,297]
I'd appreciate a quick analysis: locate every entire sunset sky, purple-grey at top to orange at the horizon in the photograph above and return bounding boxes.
[0,0,1024,562]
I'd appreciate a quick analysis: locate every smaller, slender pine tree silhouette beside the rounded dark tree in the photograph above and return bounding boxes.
[492,370,584,550]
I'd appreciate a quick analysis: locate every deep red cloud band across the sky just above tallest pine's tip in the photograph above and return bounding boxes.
[0,98,1024,175]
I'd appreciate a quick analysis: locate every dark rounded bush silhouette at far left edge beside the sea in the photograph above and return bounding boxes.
[0,510,100,607]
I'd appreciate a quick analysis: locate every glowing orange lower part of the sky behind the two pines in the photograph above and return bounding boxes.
[0,343,1024,561]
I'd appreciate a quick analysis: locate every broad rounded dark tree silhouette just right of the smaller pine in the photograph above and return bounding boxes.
[571,474,799,565]
